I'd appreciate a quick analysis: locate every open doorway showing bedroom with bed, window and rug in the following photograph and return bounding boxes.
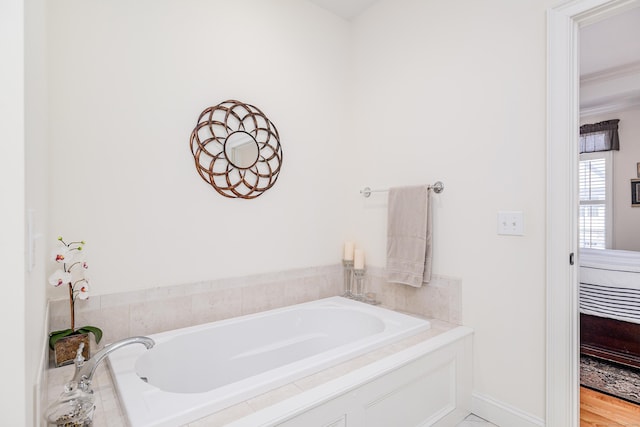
[577,3,640,423]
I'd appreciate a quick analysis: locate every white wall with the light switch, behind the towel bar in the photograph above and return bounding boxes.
[352,0,551,421]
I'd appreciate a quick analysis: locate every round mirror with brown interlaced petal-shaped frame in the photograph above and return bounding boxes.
[191,100,282,199]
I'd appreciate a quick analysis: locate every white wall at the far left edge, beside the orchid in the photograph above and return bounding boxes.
[0,0,48,427]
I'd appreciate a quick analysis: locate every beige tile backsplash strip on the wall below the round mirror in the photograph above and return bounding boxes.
[49,265,343,349]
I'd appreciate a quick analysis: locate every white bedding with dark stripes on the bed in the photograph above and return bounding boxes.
[580,249,640,323]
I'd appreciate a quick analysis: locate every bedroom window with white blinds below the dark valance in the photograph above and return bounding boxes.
[578,151,612,249]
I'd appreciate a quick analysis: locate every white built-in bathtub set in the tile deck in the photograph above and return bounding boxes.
[109,297,430,427]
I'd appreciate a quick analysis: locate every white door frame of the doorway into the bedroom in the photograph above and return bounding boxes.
[546,0,640,427]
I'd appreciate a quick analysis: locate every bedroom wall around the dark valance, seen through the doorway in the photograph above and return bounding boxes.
[580,109,640,251]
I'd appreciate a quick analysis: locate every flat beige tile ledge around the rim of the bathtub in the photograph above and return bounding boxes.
[47,319,457,427]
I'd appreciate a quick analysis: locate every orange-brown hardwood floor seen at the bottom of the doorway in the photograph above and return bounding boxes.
[580,387,640,427]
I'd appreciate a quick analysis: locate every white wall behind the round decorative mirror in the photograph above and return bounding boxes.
[48,0,354,297]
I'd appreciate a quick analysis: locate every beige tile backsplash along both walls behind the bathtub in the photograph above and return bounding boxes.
[49,264,461,358]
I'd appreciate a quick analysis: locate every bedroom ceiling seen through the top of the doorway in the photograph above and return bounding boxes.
[580,7,640,76]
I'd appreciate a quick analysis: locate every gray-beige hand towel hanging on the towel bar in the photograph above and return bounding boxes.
[386,185,431,287]
